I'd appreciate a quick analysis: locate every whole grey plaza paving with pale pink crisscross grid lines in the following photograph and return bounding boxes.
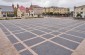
[0,18,85,55]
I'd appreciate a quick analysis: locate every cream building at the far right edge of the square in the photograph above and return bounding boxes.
[73,5,85,18]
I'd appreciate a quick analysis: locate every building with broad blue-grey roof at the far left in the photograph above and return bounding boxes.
[0,5,14,17]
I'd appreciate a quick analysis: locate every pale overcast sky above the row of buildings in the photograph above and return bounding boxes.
[0,0,85,8]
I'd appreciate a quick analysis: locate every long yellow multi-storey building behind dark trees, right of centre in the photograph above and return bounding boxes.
[43,6,70,16]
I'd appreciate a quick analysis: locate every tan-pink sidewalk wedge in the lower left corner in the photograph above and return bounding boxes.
[0,29,19,55]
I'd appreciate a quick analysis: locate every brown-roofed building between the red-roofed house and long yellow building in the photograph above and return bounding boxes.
[29,5,43,17]
